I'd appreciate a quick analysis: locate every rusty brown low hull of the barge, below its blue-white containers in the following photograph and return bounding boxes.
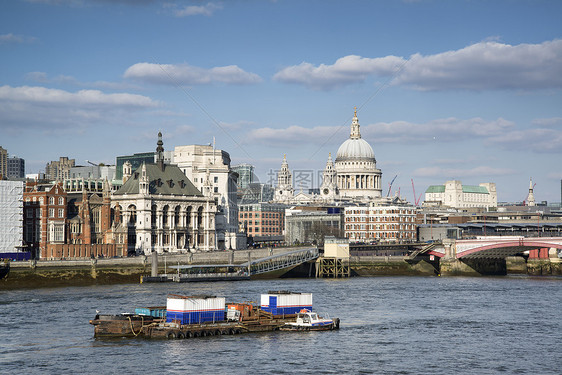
[90,315,294,339]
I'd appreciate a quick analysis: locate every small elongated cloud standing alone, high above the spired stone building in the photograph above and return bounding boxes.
[124,63,261,85]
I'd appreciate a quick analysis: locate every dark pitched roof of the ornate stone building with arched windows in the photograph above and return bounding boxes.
[114,164,203,197]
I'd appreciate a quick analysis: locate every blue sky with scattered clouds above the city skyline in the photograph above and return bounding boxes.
[0,0,562,202]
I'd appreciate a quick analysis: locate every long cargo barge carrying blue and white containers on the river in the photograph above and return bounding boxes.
[90,292,340,339]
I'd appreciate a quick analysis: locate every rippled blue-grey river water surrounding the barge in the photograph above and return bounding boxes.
[0,276,562,374]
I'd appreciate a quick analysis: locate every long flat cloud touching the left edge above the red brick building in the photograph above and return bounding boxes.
[0,86,160,131]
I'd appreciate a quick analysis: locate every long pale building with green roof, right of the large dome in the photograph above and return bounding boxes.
[423,180,498,209]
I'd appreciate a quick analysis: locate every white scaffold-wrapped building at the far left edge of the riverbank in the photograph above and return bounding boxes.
[0,180,24,253]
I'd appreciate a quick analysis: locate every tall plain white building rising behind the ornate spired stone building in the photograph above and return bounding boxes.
[172,145,246,250]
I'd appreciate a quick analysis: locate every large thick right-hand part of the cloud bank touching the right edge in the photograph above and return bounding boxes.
[394,40,562,90]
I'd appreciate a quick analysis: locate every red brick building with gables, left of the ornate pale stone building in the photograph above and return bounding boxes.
[24,183,127,259]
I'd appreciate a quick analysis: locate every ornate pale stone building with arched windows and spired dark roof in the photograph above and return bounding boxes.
[111,133,217,254]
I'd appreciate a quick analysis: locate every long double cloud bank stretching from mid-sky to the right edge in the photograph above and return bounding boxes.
[273,40,562,90]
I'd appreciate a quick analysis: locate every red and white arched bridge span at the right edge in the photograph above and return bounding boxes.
[421,236,562,259]
